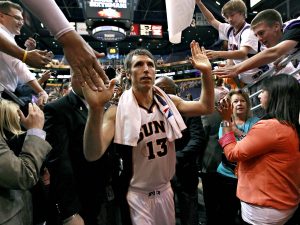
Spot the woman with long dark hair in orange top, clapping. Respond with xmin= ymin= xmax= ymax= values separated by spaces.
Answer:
xmin=219 ymin=74 xmax=300 ymax=225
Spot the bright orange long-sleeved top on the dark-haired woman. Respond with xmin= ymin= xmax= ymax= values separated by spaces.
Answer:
xmin=224 ymin=119 xmax=300 ymax=210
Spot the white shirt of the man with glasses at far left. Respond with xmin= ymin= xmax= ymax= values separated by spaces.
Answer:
xmin=0 ymin=24 xmax=35 ymax=92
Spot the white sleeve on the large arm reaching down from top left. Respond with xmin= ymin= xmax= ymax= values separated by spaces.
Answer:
xmin=22 ymin=0 xmax=74 ymax=39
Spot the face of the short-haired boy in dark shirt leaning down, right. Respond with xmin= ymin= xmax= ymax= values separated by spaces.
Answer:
xmin=253 ymin=22 xmax=280 ymax=48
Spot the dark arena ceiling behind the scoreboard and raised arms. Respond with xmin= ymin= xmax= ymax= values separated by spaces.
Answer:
xmin=15 ymin=0 xmax=300 ymax=55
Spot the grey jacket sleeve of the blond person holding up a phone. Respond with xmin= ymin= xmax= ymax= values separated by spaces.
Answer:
xmin=0 ymin=135 xmax=51 ymax=190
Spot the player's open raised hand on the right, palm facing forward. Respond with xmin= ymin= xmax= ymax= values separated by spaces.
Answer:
xmin=190 ymin=40 xmax=211 ymax=74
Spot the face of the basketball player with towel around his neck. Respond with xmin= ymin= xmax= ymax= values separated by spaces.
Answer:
xmin=129 ymin=55 xmax=155 ymax=91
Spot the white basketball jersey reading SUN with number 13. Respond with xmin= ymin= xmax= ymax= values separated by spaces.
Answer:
xmin=130 ymin=104 xmax=176 ymax=192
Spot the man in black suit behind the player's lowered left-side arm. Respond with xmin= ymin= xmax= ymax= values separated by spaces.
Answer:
xmin=44 ymin=74 xmax=117 ymax=225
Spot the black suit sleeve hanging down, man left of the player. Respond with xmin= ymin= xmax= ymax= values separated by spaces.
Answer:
xmin=44 ymin=105 xmax=80 ymax=219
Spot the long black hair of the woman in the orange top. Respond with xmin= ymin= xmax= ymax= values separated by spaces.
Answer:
xmin=262 ymin=74 xmax=300 ymax=136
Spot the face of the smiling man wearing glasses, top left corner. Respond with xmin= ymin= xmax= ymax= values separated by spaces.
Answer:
xmin=0 ymin=8 xmax=24 ymax=35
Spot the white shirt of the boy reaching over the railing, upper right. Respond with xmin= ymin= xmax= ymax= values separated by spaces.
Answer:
xmin=219 ymin=23 xmax=260 ymax=84
